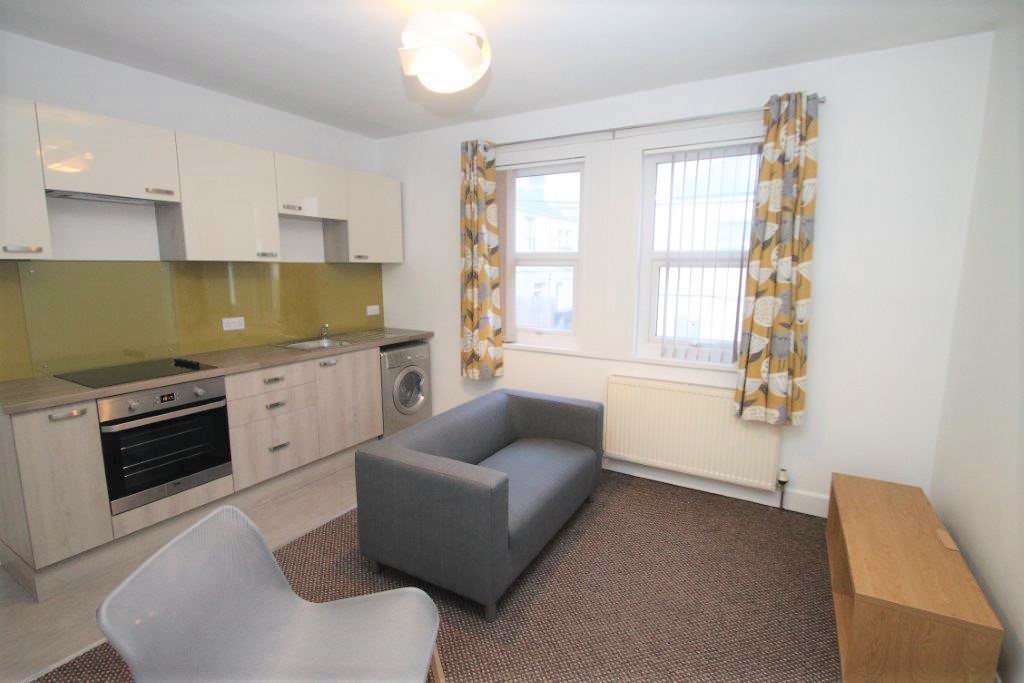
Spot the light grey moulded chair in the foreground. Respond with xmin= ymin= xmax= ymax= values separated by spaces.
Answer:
xmin=96 ymin=507 xmax=443 ymax=681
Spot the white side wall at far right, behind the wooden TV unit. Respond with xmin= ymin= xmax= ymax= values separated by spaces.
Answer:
xmin=932 ymin=4 xmax=1024 ymax=683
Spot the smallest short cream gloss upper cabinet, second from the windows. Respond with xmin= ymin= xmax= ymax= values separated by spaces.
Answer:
xmin=273 ymin=154 xmax=348 ymax=220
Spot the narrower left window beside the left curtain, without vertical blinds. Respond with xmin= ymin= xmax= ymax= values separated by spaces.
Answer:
xmin=502 ymin=163 xmax=583 ymax=339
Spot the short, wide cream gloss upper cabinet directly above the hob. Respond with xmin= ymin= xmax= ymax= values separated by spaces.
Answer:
xmin=36 ymin=103 xmax=179 ymax=202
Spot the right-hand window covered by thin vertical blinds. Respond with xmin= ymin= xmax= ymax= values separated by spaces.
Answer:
xmin=637 ymin=142 xmax=760 ymax=364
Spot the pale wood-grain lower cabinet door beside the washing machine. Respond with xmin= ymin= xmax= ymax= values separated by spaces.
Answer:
xmin=316 ymin=348 xmax=384 ymax=456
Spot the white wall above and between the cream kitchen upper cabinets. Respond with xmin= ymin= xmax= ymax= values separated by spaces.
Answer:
xmin=0 ymin=31 xmax=378 ymax=260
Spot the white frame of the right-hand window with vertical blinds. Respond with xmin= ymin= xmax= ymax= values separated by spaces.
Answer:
xmin=634 ymin=127 xmax=764 ymax=368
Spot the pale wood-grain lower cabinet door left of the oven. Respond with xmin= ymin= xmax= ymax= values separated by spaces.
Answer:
xmin=11 ymin=401 xmax=114 ymax=569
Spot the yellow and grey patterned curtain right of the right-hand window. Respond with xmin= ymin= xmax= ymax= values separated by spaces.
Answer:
xmin=735 ymin=92 xmax=818 ymax=425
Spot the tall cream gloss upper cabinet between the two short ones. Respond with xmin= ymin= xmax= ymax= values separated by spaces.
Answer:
xmin=157 ymin=132 xmax=281 ymax=261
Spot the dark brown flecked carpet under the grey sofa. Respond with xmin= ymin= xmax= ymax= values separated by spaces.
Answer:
xmin=37 ymin=472 xmax=840 ymax=682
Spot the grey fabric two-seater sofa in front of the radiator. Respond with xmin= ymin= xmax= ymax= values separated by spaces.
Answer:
xmin=355 ymin=389 xmax=604 ymax=621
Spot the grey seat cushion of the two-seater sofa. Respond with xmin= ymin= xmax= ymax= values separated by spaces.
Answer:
xmin=478 ymin=438 xmax=597 ymax=574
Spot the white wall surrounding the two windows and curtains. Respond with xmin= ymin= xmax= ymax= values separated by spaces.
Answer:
xmin=379 ymin=34 xmax=991 ymax=514
